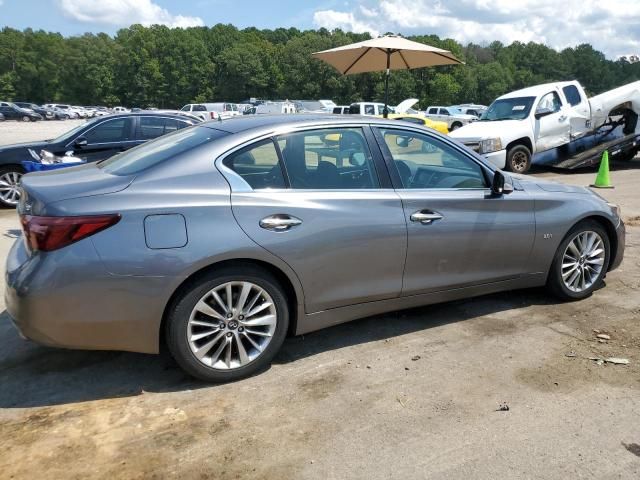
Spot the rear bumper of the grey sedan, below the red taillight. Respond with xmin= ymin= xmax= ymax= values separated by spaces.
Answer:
xmin=5 ymin=239 xmax=172 ymax=353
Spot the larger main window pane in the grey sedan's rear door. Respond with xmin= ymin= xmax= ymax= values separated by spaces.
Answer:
xmin=277 ymin=128 xmax=380 ymax=190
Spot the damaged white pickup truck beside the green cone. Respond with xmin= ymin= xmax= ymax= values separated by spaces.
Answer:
xmin=450 ymin=81 xmax=640 ymax=173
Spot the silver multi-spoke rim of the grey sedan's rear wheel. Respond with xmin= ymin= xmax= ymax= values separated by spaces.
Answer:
xmin=186 ymin=281 xmax=278 ymax=370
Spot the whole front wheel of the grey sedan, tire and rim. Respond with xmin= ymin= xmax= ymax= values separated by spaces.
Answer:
xmin=547 ymin=220 xmax=611 ymax=300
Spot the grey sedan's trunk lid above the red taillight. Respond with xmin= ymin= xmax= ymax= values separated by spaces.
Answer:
xmin=21 ymin=163 xmax=135 ymax=215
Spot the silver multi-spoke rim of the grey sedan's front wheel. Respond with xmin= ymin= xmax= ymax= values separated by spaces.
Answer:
xmin=562 ymin=230 xmax=605 ymax=293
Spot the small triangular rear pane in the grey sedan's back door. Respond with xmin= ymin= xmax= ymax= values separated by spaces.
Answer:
xmin=223 ymin=140 xmax=287 ymax=190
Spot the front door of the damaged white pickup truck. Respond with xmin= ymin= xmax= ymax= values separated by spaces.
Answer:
xmin=534 ymin=91 xmax=571 ymax=152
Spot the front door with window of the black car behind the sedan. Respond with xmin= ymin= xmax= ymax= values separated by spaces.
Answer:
xmin=67 ymin=116 xmax=139 ymax=162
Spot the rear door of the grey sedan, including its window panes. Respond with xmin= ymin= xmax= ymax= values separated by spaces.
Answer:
xmin=218 ymin=126 xmax=406 ymax=313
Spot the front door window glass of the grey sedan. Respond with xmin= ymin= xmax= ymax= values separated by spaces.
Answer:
xmin=379 ymin=129 xmax=488 ymax=189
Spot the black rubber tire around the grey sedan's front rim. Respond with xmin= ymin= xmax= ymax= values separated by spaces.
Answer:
xmin=547 ymin=220 xmax=611 ymax=301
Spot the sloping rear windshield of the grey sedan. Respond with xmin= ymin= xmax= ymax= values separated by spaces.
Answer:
xmin=98 ymin=127 xmax=229 ymax=175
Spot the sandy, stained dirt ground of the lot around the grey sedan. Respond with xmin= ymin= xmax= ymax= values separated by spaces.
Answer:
xmin=0 ymin=122 xmax=640 ymax=479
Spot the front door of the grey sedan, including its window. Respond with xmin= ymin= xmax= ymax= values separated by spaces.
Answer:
xmin=375 ymin=127 xmax=535 ymax=295
